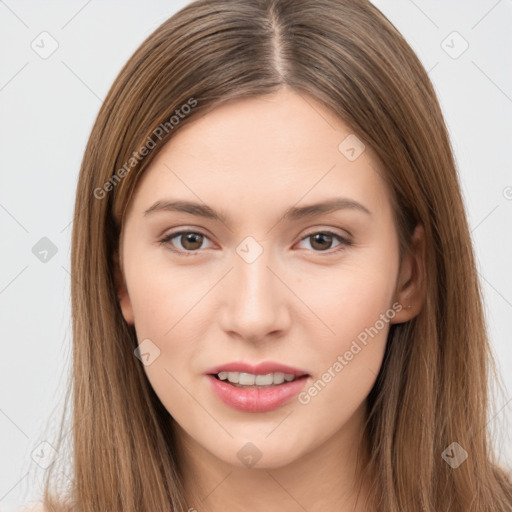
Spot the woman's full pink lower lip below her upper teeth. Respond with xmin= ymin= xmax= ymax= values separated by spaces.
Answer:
xmin=207 ymin=375 xmax=308 ymax=412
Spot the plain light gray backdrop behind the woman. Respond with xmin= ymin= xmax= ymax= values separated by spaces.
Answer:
xmin=0 ymin=0 xmax=512 ymax=511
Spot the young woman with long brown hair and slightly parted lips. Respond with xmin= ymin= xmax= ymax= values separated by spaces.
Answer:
xmin=37 ymin=0 xmax=512 ymax=512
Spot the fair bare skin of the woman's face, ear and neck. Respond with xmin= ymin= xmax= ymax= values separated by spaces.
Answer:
xmin=117 ymin=89 xmax=423 ymax=512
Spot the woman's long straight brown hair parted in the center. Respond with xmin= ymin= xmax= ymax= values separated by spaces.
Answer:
xmin=44 ymin=0 xmax=512 ymax=512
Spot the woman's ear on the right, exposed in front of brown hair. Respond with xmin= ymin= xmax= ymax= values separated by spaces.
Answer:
xmin=391 ymin=224 xmax=426 ymax=324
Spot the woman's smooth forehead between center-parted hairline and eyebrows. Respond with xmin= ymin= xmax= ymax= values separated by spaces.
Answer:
xmin=127 ymin=90 xmax=388 ymax=220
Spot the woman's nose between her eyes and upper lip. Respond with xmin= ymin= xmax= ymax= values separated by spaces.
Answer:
xmin=220 ymin=245 xmax=292 ymax=342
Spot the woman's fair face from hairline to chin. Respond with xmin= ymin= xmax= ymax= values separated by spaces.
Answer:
xmin=120 ymin=90 xmax=422 ymax=467
